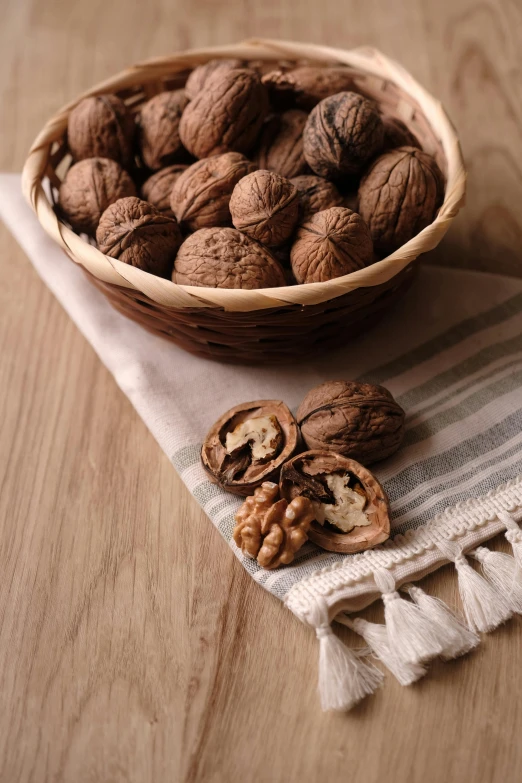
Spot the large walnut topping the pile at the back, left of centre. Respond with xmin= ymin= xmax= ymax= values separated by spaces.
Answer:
xmin=179 ymin=68 xmax=268 ymax=158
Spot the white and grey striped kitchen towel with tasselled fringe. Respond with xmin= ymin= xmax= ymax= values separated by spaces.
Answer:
xmin=0 ymin=175 xmax=522 ymax=709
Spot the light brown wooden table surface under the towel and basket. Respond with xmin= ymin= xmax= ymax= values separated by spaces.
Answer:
xmin=0 ymin=0 xmax=522 ymax=783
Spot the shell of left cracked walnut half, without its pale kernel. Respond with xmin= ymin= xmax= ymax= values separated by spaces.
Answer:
xmin=201 ymin=400 xmax=299 ymax=495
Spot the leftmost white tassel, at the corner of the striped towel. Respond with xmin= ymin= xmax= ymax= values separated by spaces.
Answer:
xmin=309 ymin=596 xmax=384 ymax=711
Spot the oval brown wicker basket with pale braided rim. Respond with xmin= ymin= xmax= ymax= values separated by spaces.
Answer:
xmin=23 ymin=41 xmax=466 ymax=363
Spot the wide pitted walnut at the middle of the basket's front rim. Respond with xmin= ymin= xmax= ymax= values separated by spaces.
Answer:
xmin=172 ymin=228 xmax=286 ymax=290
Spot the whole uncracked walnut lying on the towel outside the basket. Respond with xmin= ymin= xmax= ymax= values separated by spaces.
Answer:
xmin=296 ymin=381 xmax=404 ymax=465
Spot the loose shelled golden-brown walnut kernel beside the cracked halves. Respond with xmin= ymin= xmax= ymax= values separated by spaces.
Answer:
xmin=233 ymin=481 xmax=314 ymax=568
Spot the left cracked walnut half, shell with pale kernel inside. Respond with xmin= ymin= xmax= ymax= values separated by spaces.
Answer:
xmin=201 ymin=400 xmax=299 ymax=495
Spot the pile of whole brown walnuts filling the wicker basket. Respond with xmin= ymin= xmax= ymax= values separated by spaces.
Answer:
xmin=58 ymin=60 xmax=444 ymax=289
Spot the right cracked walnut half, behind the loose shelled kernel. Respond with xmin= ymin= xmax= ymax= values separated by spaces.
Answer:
xmin=279 ymin=451 xmax=390 ymax=554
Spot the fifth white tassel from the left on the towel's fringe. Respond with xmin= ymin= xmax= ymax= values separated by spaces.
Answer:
xmin=437 ymin=541 xmax=512 ymax=633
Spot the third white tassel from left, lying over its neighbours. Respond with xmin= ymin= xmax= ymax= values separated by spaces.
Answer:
xmin=373 ymin=568 xmax=443 ymax=664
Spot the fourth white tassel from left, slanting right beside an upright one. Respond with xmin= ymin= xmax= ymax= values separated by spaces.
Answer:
xmin=404 ymin=585 xmax=480 ymax=661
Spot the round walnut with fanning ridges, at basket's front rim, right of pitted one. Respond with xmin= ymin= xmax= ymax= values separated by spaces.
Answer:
xmin=290 ymin=207 xmax=374 ymax=283
